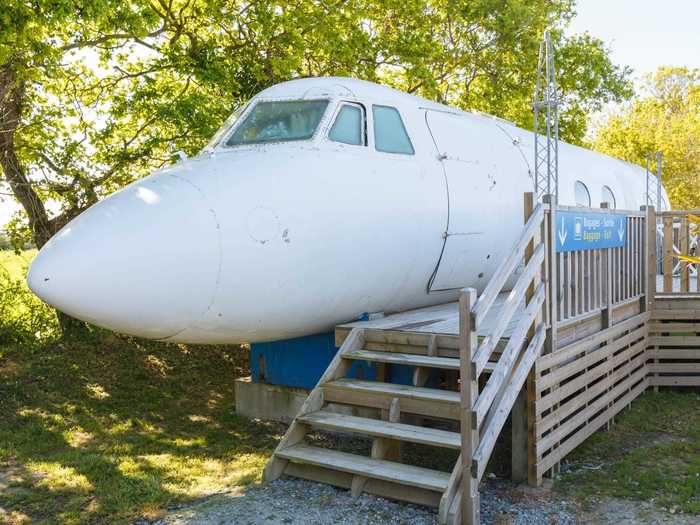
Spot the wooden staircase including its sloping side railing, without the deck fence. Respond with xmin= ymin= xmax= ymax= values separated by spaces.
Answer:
xmin=264 ymin=194 xmax=554 ymax=525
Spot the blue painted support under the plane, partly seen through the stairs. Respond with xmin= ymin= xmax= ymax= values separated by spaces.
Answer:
xmin=250 ymin=332 xmax=430 ymax=389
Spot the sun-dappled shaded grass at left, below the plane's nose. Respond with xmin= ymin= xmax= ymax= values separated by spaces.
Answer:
xmin=0 ymin=335 xmax=281 ymax=524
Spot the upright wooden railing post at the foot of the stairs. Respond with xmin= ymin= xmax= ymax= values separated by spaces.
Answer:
xmin=459 ymin=288 xmax=480 ymax=525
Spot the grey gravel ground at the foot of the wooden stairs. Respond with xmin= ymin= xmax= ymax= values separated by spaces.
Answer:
xmin=154 ymin=479 xmax=579 ymax=525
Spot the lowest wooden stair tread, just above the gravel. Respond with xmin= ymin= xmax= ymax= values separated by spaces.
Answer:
xmin=276 ymin=444 xmax=450 ymax=492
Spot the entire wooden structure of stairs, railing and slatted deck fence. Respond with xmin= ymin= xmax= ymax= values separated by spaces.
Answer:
xmin=265 ymin=193 xmax=700 ymax=525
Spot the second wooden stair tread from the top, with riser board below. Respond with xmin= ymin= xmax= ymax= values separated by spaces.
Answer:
xmin=322 ymin=379 xmax=460 ymax=419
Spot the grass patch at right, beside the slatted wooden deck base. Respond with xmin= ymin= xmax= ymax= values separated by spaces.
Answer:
xmin=557 ymin=392 xmax=700 ymax=514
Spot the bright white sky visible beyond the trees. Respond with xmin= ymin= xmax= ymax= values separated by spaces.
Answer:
xmin=0 ymin=0 xmax=700 ymax=229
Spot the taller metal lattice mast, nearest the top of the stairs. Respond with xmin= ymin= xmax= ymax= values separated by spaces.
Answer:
xmin=533 ymin=31 xmax=559 ymax=204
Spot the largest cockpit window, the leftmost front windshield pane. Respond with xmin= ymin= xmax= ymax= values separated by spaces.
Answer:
xmin=226 ymin=100 xmax=328 ymax=146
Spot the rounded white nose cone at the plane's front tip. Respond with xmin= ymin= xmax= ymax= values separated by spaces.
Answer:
xmin=27 ymin=170 xmax=221 ymax=339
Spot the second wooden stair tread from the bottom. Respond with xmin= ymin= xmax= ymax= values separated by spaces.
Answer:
xmin=299 ymin=410 xmax=461 ymax=450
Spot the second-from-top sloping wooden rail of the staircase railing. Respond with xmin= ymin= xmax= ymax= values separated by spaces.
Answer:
xmin=472 ymin=243 xmax=544 ymax=379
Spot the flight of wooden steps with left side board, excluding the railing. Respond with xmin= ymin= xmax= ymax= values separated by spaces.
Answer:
xmin=265 ymin=328 xmax=461 ymax=522
